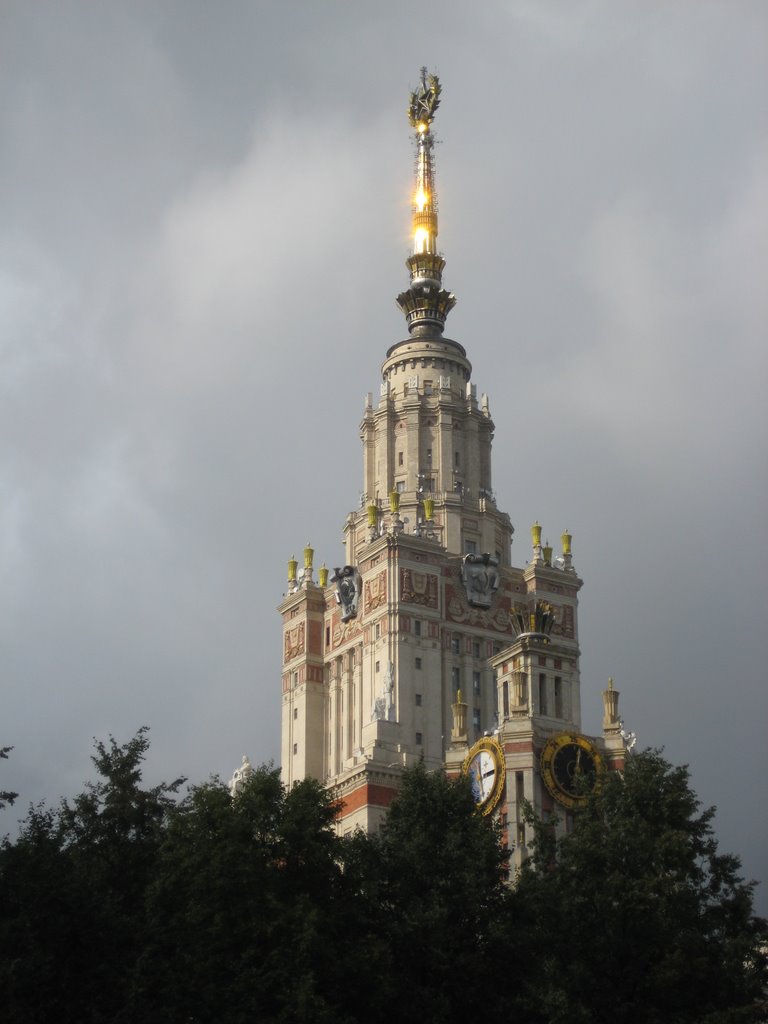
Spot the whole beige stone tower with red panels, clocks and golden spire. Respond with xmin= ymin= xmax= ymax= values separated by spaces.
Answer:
xmin=280 ymin=71 xmax=626 ymax=843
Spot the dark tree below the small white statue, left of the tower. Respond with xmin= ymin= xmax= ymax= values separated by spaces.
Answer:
xmin=135 ymin=768 xmax=354 ymax=1022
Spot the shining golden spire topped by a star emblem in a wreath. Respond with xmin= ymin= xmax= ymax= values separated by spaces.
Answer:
xmin=397 ymin=68 xmax=456 ymax=336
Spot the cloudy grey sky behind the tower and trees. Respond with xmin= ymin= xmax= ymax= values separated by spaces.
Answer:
xmin=0 ymin=0 xmax=768 ymax=912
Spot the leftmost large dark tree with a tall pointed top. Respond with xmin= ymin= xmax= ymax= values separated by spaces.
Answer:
xmin=0 ymin=729 xmax=182 ymax=1024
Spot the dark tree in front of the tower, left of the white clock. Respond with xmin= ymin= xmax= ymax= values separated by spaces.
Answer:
xmin=374 ymin=764 xmax=510 ymax=1022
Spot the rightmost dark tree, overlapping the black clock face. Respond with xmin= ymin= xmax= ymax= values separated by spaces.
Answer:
xmin=516 ymin=751 xmax=766 ymax=1024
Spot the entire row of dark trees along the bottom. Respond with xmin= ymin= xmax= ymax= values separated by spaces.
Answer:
xmin=0 ymin=730 xmax=768 ymax=1024
